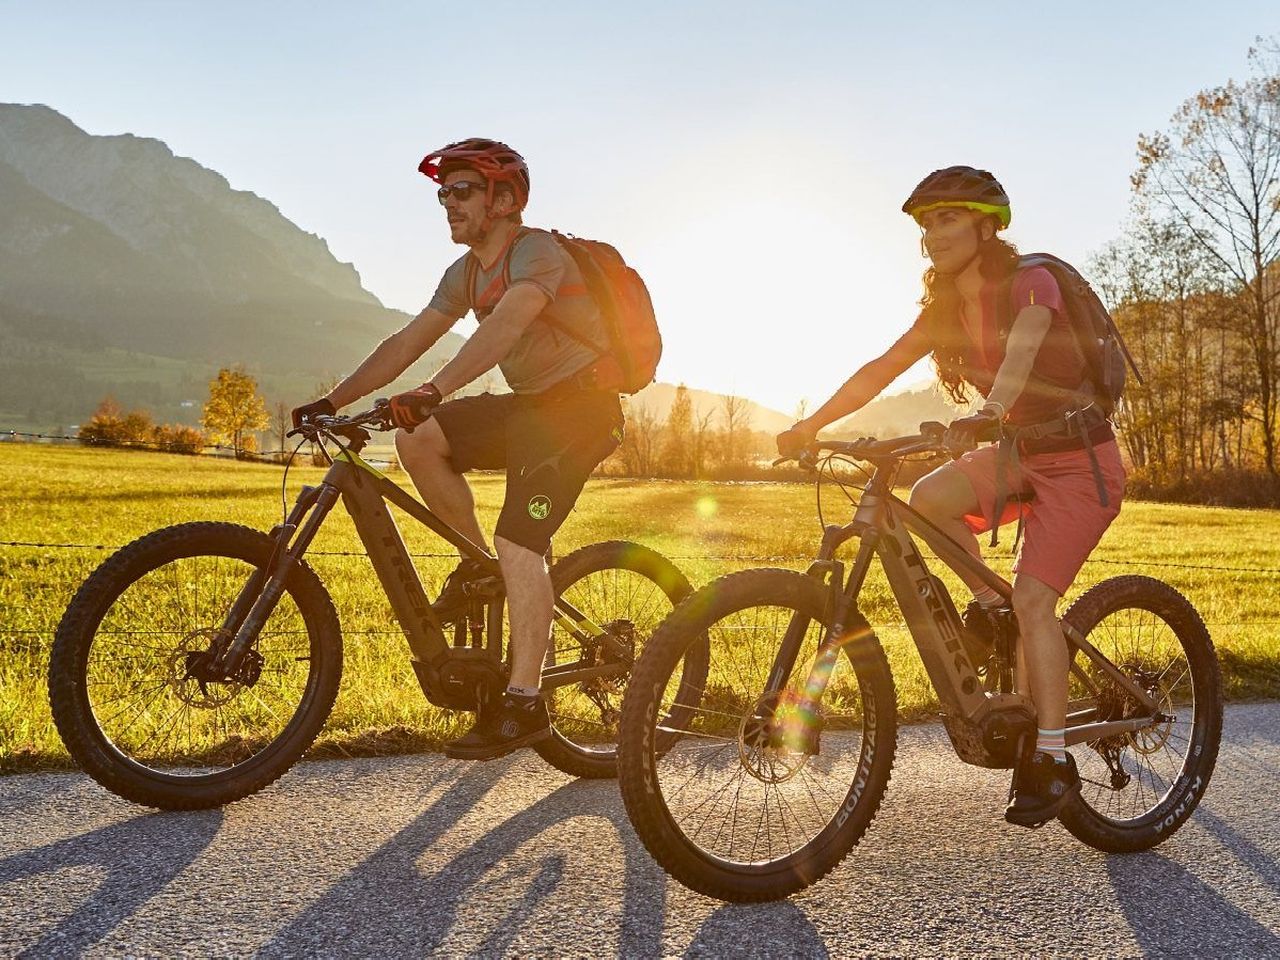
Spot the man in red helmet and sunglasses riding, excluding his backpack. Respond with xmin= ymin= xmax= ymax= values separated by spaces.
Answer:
xmin=293 ymin=138 xmax=622 ymax=760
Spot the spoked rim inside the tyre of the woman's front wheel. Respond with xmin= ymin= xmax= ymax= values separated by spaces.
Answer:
xmin=654 ymin=604 xmax=868 ymax=873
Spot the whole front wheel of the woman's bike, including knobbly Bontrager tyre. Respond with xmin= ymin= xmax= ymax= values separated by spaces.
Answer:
xmin=620 ymin=570 xmax=897 ymax=902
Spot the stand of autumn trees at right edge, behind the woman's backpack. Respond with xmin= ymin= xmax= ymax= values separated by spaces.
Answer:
xmin=1091 ymin=40 xmax=1280 ymax=506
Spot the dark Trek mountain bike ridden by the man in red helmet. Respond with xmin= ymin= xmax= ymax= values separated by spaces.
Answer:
xmin=49 ymin=401 xmax=707 ymax=809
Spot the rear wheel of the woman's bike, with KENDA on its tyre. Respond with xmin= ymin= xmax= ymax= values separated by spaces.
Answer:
xmin=1059 ymin=576 xmax=1222 ymax=852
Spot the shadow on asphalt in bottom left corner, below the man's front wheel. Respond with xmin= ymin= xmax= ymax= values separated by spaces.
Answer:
xmin=0 ymin=810 xmax=223 ymax=956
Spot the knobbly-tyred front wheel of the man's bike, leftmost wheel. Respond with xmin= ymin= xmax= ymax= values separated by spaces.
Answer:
xmin=49 ymin=524 xmax=342 ymax=810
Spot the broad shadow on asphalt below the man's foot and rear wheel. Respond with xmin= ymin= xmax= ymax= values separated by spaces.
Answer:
xmin=260 ymin=763 xmax=667 ymax=957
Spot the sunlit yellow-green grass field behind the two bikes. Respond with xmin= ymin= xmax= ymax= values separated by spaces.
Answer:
xmin=0 ymin=444 xmax=1280 ymax=772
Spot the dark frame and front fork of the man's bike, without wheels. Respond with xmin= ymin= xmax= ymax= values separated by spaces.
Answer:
xmin=219 ymin=443 xmax=626 ymax=709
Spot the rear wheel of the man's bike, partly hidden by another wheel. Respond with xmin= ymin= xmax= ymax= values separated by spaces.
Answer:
xmin=534 ymin=540 xmax=707 ymax=778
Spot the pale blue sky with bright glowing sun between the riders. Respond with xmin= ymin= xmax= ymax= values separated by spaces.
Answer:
xmin=0 ymin=0 xmax=1280 ymax=412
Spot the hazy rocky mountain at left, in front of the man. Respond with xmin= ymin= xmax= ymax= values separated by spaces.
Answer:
xmin=0 ymin=104 xmax=462 ymax=421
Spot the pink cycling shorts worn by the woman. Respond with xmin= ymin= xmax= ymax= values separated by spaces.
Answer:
xmin=943 ymin=440 xmax=1125 ymax=595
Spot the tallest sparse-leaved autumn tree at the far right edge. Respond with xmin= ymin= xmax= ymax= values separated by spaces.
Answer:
xmin=1133 ymin=46 xmax=1280 ymax=476
